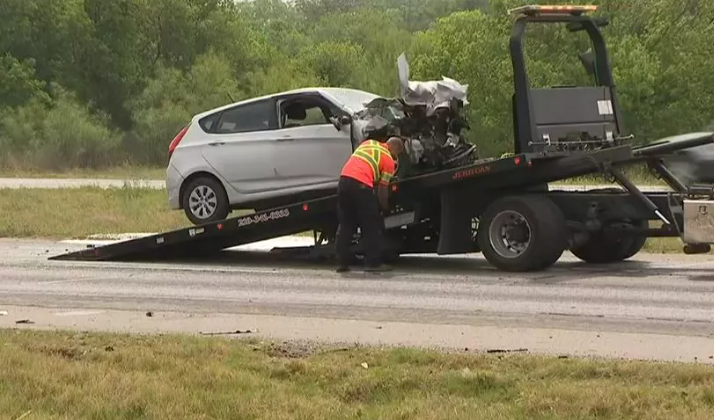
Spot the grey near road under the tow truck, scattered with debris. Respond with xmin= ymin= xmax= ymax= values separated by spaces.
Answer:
xmin=0 ymin=239 xmax=714 ymax=363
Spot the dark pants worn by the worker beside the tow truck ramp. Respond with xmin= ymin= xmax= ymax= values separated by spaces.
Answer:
xmin=336 ymin=177 xmax=384 ymax=266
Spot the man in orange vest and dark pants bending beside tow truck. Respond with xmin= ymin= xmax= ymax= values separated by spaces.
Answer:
xmin=336 ymin=137 xmax=404 ymax=273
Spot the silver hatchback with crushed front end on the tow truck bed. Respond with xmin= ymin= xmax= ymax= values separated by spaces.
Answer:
xmin=166 ymin=55 xmax=476 ymax=224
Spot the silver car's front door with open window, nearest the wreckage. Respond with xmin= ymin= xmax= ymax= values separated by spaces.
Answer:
xmin=273 ymin=94 xmax=352 ymax=190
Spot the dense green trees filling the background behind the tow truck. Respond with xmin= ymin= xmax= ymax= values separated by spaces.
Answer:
xmin=0 ymin=0 xmax=714 ymax=170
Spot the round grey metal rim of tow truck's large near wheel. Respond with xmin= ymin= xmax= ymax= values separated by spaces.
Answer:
xmin=488 ymin=210 xmax=531 ymax=258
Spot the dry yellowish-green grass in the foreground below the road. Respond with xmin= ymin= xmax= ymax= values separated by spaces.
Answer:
xmin=0 ymin=330 xmax=714 ymax=420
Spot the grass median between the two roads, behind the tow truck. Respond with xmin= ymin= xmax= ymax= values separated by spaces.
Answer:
xmin=0 ymin=187 xmax=682 ymax=253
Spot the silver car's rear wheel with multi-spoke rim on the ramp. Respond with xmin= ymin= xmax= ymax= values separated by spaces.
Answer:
xmin=181 ymin=176 xmax=230 ymax=225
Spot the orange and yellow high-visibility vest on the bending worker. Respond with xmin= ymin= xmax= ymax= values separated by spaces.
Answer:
xmin=341 ymin=140 xmax=396 ymax=187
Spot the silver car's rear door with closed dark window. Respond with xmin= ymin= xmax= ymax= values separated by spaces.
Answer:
xmin=202 ymin=99 xmax=280 ymax=194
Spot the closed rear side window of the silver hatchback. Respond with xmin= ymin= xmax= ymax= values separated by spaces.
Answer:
xmin=214 ymin=100 xmax=277 ymax=134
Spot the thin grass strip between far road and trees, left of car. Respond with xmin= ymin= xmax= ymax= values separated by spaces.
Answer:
xmin=0 ymin=165 xmax=166 ymax=180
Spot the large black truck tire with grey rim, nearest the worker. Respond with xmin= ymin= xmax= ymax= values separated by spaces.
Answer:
xmin=477 ymin=195 xmax=568 ymax=272
